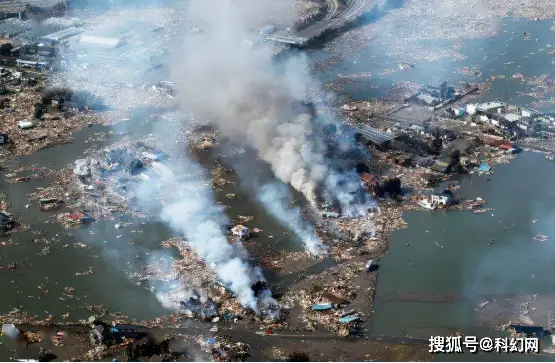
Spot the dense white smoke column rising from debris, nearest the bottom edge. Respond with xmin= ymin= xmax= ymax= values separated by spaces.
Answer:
xmin=138 ymin=161 xmax=262 ymax=311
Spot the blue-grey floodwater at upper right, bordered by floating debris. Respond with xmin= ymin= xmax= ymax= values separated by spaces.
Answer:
xmin=310 ymin=20 xmax=555 ymax=111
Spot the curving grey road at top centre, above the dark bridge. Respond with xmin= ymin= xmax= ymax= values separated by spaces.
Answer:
xmin=266 ymin=0 xmax=387 ymax=45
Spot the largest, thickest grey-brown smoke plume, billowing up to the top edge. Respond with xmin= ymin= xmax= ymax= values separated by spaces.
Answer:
xmin=174 ymin=0 xmax=329 ymax=206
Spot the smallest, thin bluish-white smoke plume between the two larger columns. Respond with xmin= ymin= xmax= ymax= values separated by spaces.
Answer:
xmin=258 ymin=183 xmax=326 ymax=255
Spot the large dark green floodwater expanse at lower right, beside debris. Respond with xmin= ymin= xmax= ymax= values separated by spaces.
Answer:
xmin=371 ymin=152 xmax=555 ymax=361
